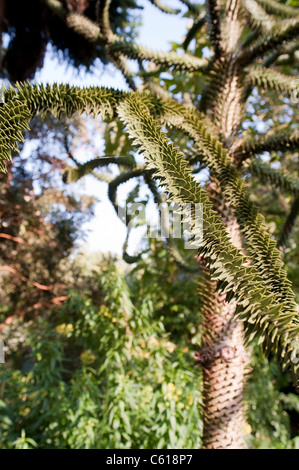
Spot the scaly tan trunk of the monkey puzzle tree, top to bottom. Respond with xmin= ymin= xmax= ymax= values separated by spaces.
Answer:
xmin=197 ymin=0 xmax=249 ymax=449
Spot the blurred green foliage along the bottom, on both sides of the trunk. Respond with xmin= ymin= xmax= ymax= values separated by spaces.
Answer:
xmin=0 ymin=235 xmax=299 ymax=449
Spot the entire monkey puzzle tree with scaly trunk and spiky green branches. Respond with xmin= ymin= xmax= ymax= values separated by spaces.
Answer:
xmin=0 ymin=0 xmax=299 ymax=448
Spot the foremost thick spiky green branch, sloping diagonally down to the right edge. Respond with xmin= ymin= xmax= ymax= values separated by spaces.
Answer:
xmin=118 ymin=96 xmax=299 ymax=388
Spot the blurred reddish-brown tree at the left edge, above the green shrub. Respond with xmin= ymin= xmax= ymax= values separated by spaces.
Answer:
xmin=0 ymin=114 xmax=94 ymax=323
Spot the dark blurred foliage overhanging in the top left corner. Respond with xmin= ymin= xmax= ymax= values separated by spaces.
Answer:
xmin=0 ymin=0 xmax=142 ymax=82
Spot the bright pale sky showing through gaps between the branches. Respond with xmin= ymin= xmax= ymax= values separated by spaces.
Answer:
xmin=35 ymin=0 xmax=189 ymax=255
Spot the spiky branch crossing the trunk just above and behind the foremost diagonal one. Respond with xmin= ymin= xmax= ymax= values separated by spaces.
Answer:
xmin=149 ymin=101 xmax=296 ymax=318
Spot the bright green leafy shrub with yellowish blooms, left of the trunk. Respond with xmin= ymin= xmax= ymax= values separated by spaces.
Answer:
xmin=0 ymin=260 xmax=201 ymax=448
